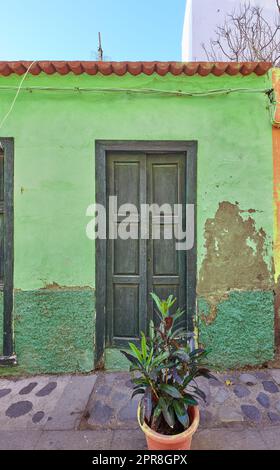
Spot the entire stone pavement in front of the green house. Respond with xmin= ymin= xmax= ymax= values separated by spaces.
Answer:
xmin=0 ymin=369 xmax=280 ymax=450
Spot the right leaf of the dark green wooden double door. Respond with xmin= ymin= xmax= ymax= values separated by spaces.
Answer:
xmin=147 ymin=154 xmax=186 ymax=326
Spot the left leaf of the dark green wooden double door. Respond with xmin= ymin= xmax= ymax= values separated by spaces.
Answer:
xmin=106 ymin=152 xmax=146 ymax=347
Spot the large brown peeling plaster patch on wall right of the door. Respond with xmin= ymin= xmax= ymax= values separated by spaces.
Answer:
xmin=198 ymin=201 xmax=273 ymax=295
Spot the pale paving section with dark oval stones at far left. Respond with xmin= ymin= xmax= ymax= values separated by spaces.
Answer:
xmin=0 ymin=375 xmax=96 ymax=431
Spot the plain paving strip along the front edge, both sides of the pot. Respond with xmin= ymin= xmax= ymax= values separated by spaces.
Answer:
xmin=0 ymin=427 xmax=280 ymax=451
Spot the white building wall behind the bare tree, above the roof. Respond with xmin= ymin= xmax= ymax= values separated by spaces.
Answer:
xmin=182 ymin=0 xmax=277 ymax=62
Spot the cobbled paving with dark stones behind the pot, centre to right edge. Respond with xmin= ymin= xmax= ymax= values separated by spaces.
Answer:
xmin=82 ymin=370 xmax=280 ymax=432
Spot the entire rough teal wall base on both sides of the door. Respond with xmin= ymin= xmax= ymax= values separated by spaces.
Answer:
xmin=0 ymin=289 xmax=274 ymax=375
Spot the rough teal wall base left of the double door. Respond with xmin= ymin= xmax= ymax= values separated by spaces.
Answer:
xmin=1 ymin=289 xmax=95 ymax=373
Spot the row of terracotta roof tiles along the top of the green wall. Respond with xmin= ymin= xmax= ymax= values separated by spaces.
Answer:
xmin=0 ymin=61 xmax=272 ymax=77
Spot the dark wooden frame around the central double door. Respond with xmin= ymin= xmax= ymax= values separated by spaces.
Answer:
xmin=95 ymin=140 xmax=197 ymax=369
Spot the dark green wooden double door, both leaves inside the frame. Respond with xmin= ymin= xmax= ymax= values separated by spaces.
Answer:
xmin=106 ymin=151 xmax=186 ymax=347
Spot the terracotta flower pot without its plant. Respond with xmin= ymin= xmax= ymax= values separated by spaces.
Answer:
xmin=137 ymin=404 xmax=199 ymax=450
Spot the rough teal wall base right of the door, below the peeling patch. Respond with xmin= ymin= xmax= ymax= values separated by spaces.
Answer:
xmin=198 ymin=291 xmax=274 ymax=369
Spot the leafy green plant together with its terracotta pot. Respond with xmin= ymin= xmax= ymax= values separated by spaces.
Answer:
xmin=122 ymin=293 xmax=215 ymax=450
